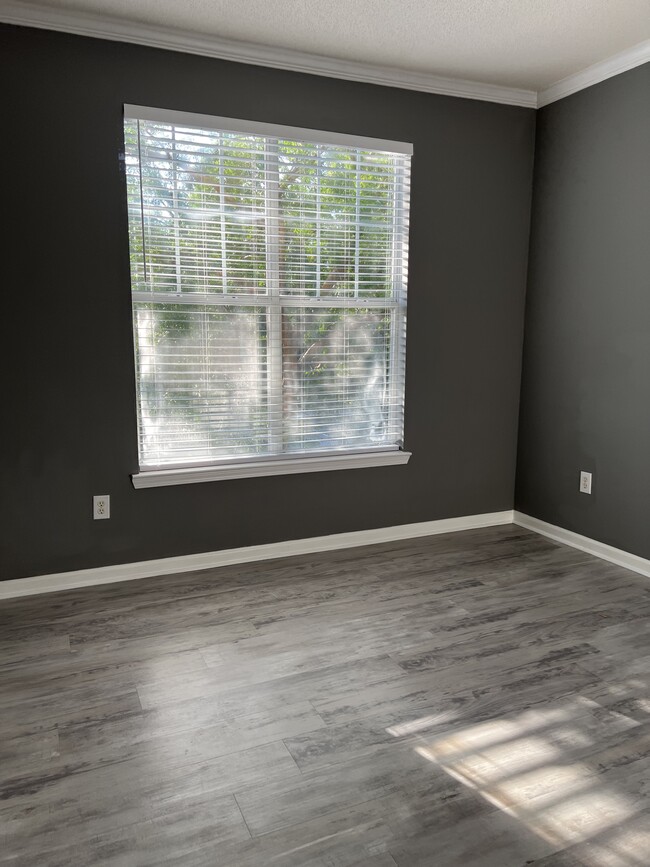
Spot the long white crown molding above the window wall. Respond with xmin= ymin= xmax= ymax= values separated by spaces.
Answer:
xmin=0 ymin=0 xmax=537 ymax=108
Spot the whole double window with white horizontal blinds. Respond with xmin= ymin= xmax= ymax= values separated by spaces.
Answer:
xmin=124 ymin=106 xmax=410 ymax=487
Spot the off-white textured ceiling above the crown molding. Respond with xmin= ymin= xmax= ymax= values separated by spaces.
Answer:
xmin=10 ymin=0 xmax=650 ymax=90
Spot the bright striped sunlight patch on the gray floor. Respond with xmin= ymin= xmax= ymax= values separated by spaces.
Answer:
xmin=388 ymin=697 xmax=650 ymax=867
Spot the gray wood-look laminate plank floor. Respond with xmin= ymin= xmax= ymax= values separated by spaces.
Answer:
xmin=0 ymin=526 xmax=650 ymax=867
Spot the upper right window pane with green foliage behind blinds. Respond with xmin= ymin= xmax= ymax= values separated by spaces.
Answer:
xmin=278 ymin=140 xmax=394 ymax=298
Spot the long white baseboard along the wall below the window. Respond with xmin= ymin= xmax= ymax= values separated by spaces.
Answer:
xmin=0 ymin=511 xmax=512 ymax=599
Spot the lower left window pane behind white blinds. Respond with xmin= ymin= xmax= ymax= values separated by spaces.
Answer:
xmin=134 ymin=304 xmax=269 ymax=466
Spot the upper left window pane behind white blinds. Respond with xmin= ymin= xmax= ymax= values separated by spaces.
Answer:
xmin=126 ymin=121 xmax=266 ymax=294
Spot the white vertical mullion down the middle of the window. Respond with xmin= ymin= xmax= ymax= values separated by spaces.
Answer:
xmin=266 ymin=139 xmax=284 ymax=453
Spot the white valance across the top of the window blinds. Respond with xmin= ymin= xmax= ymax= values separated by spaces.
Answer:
xmin=124 ymin=105 xmax=413 ymax=156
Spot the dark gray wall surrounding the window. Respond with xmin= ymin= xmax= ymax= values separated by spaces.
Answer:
xmin=0 ymin=26 xmax=535 ymax=578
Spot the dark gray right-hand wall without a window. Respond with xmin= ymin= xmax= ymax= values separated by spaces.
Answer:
xmin=516 ymin=64 xmax=650 ymax=557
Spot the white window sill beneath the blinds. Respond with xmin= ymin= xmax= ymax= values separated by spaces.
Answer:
xmin=131 ymin=449 xmax=411 ymax=488
